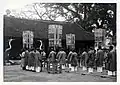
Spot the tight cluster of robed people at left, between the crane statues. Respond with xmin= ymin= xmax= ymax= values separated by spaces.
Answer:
xmin=20 ymin=49 xmax=46 ymax=72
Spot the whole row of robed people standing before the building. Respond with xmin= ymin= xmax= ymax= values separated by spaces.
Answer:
xmin=20 ymin=46 xmax=117 ymax=76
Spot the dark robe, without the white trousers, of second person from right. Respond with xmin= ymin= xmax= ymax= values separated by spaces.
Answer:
xmin=96 ymin=50 xmax=104 ymax=67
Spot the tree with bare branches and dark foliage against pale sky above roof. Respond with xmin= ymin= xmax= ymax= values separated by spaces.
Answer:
xmin=5 ymin=3 xmax=116 ymax=35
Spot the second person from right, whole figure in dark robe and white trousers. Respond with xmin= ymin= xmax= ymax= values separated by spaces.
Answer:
xmin=96 ymin=46 xmax=104 ymax=72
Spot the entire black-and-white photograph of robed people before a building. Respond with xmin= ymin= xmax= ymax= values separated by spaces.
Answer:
xmin=3 ymin=0 xmax=117 ymax=82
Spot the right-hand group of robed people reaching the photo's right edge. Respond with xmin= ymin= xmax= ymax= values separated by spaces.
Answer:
xmin=80 ymin=46 xmax=117 ymax=76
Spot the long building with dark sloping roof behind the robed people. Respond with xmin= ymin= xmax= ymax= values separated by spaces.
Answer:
xmin=3 ymin=16 xmax=94 ymax=57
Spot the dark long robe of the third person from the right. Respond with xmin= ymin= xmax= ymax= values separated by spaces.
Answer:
xmin=87 ymin=50 xmax=95 ymax=67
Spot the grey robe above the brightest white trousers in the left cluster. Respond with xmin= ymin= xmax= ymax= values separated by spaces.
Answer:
xmin=34 ymin=51 xmax=42 ymax=67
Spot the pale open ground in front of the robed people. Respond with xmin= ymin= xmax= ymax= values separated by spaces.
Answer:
xmin=4 ymin=65 xmax=116 ymax=82
